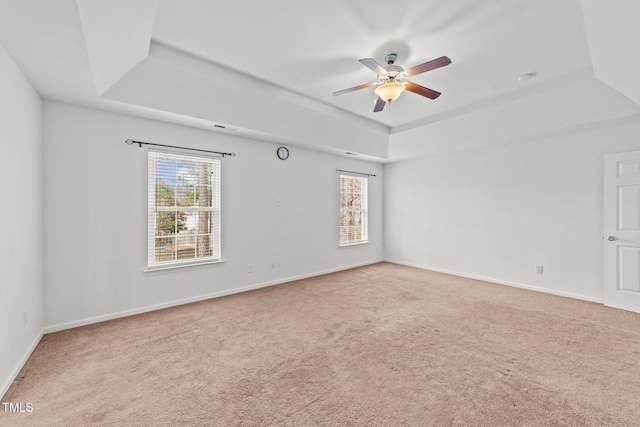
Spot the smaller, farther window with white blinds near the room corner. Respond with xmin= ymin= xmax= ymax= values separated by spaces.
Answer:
xmin=340 ymin=175 xmax=368 ymax=246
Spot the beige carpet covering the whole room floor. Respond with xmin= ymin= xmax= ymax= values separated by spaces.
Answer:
xmin=0 ymin=263 xmax=640 ymax=426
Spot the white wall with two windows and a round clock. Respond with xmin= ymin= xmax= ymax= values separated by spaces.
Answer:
xmin=44 ymin=101 xmax=383 ymax=331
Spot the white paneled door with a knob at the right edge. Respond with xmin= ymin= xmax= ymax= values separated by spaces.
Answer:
xmin=603 ymin=151 xmax=640 ymax=312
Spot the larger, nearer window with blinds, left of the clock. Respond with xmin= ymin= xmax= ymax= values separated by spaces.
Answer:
xmin=148 ymin=151 xmax=220 ymax=269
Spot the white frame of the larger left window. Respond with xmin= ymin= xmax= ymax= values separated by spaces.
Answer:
xmin=145 ymin=149 xmax=224 ymax=272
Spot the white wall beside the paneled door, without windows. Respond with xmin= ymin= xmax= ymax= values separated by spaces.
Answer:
xmin=384 ymin=116 xmax=640 ymax=301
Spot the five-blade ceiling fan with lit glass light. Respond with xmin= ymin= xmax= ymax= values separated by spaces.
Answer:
xmin=333 ymin=53 xmax=451 ymax=113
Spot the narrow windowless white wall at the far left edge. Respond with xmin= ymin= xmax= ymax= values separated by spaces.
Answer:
xmin=0 ymin=46 xmax=43 ymax=398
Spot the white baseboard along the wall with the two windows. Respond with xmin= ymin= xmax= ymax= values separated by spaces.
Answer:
xmin=44 ymin=259 xmax=384 ymax=334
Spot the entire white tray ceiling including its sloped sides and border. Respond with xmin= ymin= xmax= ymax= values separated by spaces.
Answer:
xmin=0 ymin=0 xmax=638 ymax=161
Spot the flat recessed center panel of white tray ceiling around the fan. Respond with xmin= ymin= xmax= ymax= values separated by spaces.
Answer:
xmin=152 ymin=0 xmax=591 ymax=126
